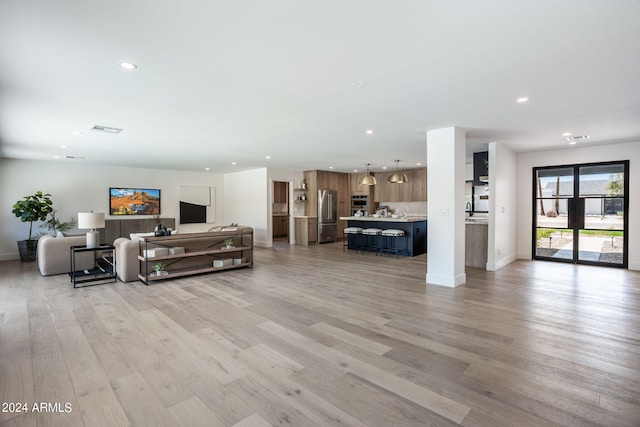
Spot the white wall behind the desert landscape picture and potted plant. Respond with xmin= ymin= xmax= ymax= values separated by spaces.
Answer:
xmin=0 ymin=159 xmax=224 ymax=260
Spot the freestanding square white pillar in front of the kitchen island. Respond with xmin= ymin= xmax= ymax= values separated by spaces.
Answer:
xmin=427 ymin=127 xmax=467 ymax=287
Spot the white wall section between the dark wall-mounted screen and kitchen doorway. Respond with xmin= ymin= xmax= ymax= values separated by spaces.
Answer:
xmin=224 ymin=168 xmax=273 ymax=247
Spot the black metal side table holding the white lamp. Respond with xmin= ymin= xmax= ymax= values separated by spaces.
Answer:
xmin=69 ymin=245 xmax=116 ymax=288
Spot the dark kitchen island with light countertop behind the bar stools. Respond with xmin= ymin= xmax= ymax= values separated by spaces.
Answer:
xmin=339 ymin=216 xmax=427 ymax=256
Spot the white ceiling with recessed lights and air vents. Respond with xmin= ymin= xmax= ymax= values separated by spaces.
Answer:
xmin=0 ymin=0 xmax=640 ymax=172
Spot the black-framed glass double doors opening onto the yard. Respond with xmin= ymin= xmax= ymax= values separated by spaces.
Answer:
xmin=532 ymin=161 xmax=629 ymax=268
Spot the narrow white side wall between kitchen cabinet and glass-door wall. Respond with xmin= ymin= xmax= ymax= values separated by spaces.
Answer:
xmin=487 ymin=142 xmax=517 ymax=271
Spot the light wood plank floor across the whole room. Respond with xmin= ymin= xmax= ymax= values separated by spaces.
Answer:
xmin=0 ymin=243 xmax=640 ymax=427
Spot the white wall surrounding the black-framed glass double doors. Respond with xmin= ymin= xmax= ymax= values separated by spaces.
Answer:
xmin=517 ymin=142 xmax=640 ymax=270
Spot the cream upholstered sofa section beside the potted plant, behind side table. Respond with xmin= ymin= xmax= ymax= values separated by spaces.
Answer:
xmin=36 ymin=234 xmax=96 ymax=276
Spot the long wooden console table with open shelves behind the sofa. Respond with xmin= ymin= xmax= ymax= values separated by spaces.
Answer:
xmin=138 ymin=226 xmax=253 ymax=285
